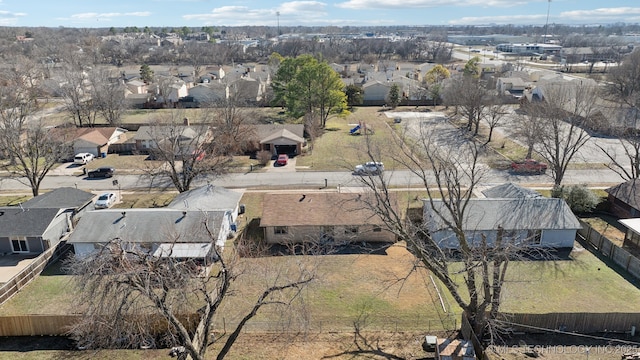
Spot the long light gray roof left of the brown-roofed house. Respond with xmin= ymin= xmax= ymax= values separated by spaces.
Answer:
xmin=69 ymin=208 xmax=224 ymax=243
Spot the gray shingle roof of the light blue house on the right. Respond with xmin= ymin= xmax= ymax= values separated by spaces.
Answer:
xmin=424 ymin=197 xmax=581 ymax=231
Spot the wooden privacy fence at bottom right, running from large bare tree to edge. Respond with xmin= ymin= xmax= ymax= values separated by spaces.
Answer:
xmin=501 ymin=313 xmax=640 ymax=334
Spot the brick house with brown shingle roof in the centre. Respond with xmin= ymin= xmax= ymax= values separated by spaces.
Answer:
xmin=260 ymin=192 xmax=397 ymax=244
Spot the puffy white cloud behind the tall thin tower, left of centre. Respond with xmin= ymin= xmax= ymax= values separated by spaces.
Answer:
xmin=182 ymin=1 xmax=328 ymax=26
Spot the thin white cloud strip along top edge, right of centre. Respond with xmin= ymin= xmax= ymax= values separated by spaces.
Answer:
xmin=336 ymin=0 xmax=532 ymax=9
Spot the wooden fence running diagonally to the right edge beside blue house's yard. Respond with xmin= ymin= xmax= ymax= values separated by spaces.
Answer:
xmin=578 ymin=220 xmax=640 ymax=280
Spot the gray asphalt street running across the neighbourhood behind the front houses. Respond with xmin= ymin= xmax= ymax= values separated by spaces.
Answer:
xmin=0 ymin=169 xmax=622 ymax=193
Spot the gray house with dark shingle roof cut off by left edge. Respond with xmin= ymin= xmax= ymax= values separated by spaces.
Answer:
xmin=0 ymin=206 xmax=71 ymax=254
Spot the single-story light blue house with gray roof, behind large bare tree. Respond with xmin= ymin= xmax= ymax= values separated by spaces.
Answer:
xmin=423 ymin=197 xmax=581 ymax=250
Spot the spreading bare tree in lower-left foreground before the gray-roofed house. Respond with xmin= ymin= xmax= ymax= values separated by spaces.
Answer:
xmin=66 ymin=225 xmax=315 ymax=360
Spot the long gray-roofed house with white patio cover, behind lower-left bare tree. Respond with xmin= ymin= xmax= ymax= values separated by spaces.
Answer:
xmin=68 ymin=208 xmax=231 ymax=263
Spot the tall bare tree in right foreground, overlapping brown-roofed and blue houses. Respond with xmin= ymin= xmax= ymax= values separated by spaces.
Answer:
xmin=362 ymin=127 xmax=527 ymax=358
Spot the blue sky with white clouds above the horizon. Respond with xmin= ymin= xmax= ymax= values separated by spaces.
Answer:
xmin=0 ymin=0 xmax=640 ymax=28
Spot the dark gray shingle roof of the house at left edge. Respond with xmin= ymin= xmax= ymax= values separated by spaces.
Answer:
xmin=0 ymin=206 xmax=60 ymax=237
